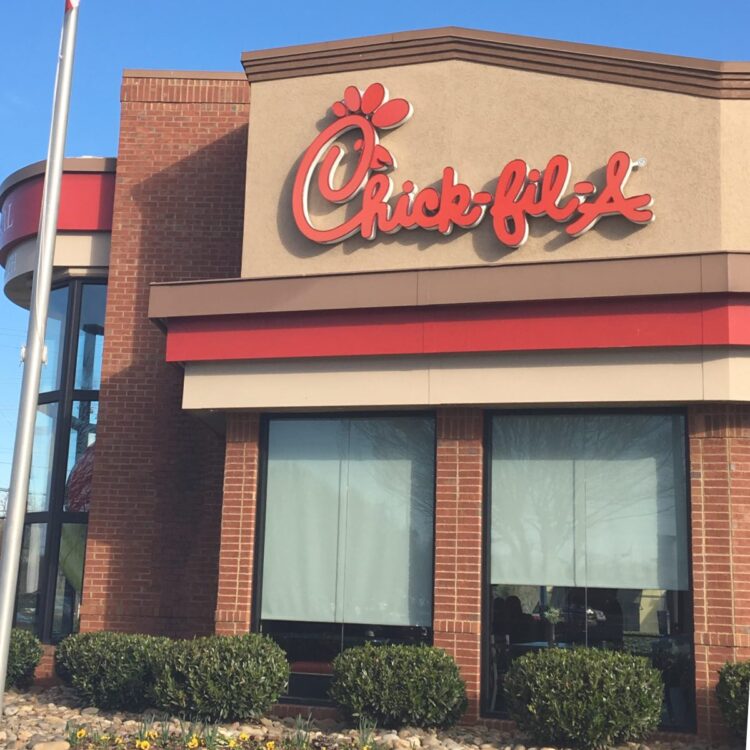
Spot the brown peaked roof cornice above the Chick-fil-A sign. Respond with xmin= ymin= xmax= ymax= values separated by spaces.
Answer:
xmin=241 ymin=27 xmax=750 ymax=99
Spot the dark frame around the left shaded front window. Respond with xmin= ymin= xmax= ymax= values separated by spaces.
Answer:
xmin=250 ymin=409 xmax=438 ymax=705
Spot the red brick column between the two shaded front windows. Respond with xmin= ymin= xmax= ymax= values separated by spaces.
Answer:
xmin=433 ymin=409 xmax=483 ymax=721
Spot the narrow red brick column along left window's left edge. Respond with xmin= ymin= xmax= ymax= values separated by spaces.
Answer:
xmin=216 ymin=413 xmax=260 ymax=635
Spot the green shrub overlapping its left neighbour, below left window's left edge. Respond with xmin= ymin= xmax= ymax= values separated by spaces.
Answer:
xmin=154 ymin=633 xmax=289 ymax=721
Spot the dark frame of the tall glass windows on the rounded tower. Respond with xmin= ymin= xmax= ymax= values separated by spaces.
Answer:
xmin=13 ymin=276 xmax=107 ymax=644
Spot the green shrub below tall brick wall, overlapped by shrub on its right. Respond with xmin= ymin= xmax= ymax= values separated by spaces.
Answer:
xmin=55 ymin=632 xmax=169 ymax=711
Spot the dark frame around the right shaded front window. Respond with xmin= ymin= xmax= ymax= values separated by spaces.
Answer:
xmin=479 ymin=406 xmax=697 ymax=734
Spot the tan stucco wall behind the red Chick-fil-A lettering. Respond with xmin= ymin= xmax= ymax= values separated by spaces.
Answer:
xmin=242 ymin=61 xmax=750 ymax=277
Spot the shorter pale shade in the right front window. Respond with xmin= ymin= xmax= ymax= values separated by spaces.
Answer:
xmin=491 ymin=414 xmax=688 ymax=590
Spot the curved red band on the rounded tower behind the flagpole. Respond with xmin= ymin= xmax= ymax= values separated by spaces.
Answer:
xmin=0 ymin=172 xmax=115 ymax=264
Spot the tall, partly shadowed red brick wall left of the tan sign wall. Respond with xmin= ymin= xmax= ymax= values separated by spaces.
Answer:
xmin=81 ymin=73 xmax=249 ymax=635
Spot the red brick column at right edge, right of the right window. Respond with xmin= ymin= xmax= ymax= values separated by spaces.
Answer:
xmin=688 ymin=404 xmax=750 ymax=741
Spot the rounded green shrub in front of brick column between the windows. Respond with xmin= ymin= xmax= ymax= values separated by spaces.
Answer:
xmin=331 ymin=644 xmax=466 ymax=727
